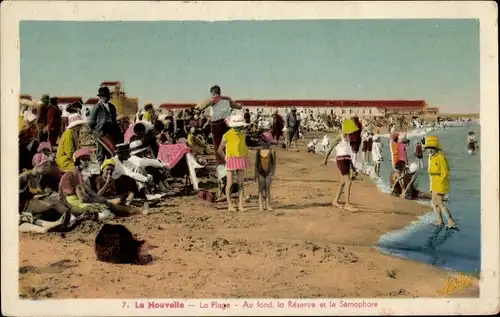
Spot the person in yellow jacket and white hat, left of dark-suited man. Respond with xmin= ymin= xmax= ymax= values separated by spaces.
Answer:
xmin=56 ymin=115 xmax=87 ymax=172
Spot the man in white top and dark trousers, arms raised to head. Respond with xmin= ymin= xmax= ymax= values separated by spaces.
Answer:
xmin=195 ymin=86 xmax=242 ymax=165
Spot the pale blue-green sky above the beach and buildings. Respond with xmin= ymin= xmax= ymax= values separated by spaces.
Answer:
xmin=20 ymin=19 xmax=480 ymax=113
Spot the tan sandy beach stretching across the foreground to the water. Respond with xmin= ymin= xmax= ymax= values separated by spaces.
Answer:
xmin=19 ymin=137 xmax=479 ymax=299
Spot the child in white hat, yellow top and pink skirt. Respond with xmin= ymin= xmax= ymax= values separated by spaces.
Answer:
xmin=218 ymin=114 xmax=250 ymax=211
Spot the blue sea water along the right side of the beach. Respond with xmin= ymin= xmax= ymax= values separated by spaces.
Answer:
xmin=372 ymin=124 xmax=481 ymax=274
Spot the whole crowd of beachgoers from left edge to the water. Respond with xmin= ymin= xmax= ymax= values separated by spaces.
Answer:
xmin=19 ymin=86 xmax=468 ymax=256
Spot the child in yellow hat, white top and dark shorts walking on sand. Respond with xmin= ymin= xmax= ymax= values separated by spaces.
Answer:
xmin=323 ymin=119 xmax=359 ymax=211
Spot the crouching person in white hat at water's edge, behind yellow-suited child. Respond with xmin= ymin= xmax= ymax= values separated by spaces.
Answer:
xmin=390 ymin=161 xmax=448 ymax=200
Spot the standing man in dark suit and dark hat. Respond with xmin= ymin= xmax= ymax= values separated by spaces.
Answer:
xmin=88 ymin=87 xmax=123 ymax=165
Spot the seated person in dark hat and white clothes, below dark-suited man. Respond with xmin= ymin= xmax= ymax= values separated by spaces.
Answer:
xmin=111 ymin=143 xmax=154 ymax=201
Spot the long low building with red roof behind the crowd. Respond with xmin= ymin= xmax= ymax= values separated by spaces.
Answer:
xmin=160 ymin=99 xmax=439 ymax=117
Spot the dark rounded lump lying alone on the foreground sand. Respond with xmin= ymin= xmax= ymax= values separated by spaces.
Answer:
xmin=95 ymin=224 xmax=152 ymax=265
